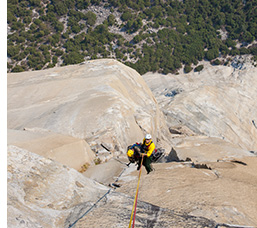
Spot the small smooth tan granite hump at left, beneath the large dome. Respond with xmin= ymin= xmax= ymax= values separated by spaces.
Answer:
xmin=7 ymin=129 xmax=95 ymax=170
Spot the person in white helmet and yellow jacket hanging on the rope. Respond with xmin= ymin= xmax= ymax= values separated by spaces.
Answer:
xmin=137 ymin=134 xmax=155 ymax=174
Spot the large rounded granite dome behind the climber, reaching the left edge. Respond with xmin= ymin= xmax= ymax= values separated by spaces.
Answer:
xmin=8 ymin=59 xmax=171 ymax=163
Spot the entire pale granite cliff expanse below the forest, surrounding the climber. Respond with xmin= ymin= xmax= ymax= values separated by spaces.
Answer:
xmin=7 ymin=60 xmax=257 ymax=228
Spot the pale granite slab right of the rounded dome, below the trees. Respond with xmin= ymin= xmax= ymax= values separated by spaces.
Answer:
xmin=143 ymin=57 xmax=257 ymax=151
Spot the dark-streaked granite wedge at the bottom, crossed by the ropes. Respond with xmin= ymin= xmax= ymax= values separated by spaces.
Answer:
xmin=76 ymin=192 xmax=217 ymax=228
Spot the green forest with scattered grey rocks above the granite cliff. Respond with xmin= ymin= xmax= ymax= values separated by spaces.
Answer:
xmin=7 ymin=0 xmax=257 ymax=74
